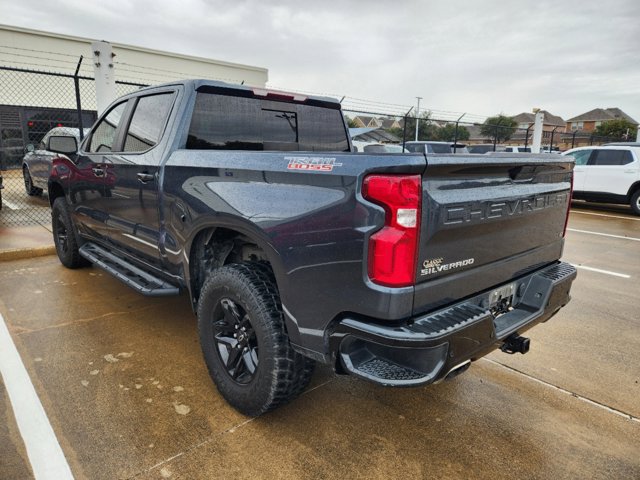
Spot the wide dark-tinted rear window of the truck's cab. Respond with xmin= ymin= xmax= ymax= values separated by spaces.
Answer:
xmin=187 ymin=92 xmax=349 ymax=151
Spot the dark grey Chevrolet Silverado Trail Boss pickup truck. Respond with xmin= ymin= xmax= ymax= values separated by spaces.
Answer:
xmin=48 ymin=80 xmax=576 ymax=415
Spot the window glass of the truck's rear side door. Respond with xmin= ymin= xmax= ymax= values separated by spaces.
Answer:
xmin=124 ymin=92 xmax=173 ymax=152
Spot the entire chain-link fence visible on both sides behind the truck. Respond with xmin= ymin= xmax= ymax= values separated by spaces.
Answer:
xmin=0 ymin=59 xmax=611 ymax=226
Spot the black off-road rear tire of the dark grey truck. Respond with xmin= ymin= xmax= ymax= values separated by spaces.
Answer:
xmin=197 ymin=263 xmax=312 ymax=416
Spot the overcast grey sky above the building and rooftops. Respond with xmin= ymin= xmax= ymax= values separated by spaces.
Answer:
xmin=0 ymin=0 xmax=640 ymax=121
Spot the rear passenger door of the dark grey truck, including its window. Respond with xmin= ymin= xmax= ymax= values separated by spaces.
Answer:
xmin=100 ymin=89 xmax=176 ymax=263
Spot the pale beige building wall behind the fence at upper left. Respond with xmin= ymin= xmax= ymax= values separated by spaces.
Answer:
xmin=0 ymin=25 xmax=268 ymax=110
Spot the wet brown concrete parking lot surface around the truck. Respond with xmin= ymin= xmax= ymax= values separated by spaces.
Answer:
xmin=0 ymin=204 xmax=640 ymax=479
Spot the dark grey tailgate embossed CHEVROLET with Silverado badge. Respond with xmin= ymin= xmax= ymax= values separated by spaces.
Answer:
xmin=414 ymin=154 xmax=573 ymax=313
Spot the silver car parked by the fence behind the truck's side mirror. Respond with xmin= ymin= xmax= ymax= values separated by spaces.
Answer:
xmin=22 ymin=127 xmax=90 ymax=195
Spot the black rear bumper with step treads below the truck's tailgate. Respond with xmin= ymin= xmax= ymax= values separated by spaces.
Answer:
xmin=331 ymin=262 xmax=576 ymax=386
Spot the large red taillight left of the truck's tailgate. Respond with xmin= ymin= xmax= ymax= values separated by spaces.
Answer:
xmin=362 ymin=175 xmax=422 ymax=287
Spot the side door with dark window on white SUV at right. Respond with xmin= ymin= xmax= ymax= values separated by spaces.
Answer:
xmin=584 ymin=148 xmax=639 ymax=195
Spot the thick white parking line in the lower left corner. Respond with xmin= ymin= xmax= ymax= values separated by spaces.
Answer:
xmin=0 ymin=315 xmax=73 ymax=480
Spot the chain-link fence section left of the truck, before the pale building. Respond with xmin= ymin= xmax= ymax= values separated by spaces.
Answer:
xmin=0 ymin=67 xmax=146 ymax=226
